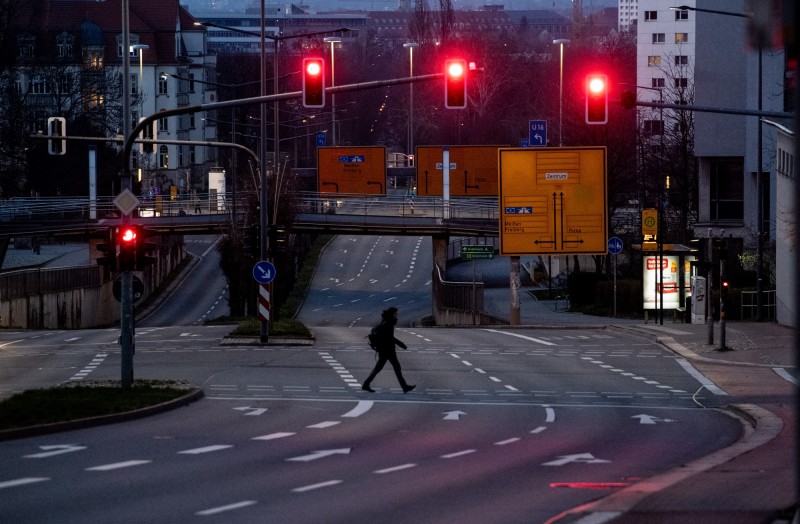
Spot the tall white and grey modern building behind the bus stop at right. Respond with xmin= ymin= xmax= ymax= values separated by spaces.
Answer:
xmin=636 ymin=0 xmax=792 ymax=324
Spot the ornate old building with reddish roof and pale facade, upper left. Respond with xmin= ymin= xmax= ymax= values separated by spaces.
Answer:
xmin=9 ymin=0 xmax=216 ymax=195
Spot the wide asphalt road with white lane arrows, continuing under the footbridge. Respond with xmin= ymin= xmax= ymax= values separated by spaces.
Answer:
xmin=0 ymin=236 xmax=742 ymax=523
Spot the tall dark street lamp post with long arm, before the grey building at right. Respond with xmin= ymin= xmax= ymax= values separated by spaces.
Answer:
xmin=670 ymin=5 xmax=764 ymax=322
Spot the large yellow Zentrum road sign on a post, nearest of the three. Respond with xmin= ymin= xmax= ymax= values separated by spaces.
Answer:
xmin=499 ymin=147 xmax=608 ymax=255
